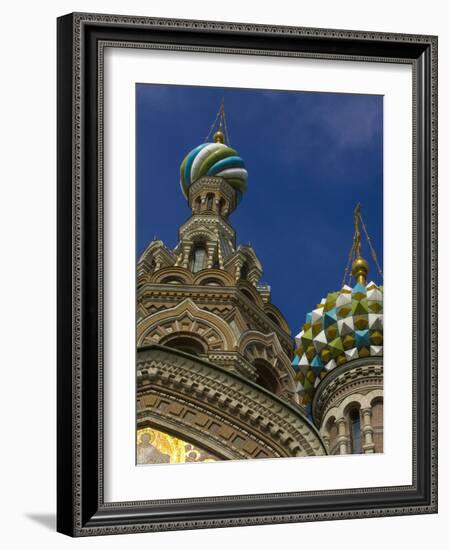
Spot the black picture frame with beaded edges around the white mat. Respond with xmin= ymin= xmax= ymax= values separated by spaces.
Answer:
xmin=57 ymin=13 xmax=437 ymax=536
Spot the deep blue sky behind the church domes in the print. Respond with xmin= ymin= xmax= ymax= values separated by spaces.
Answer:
xmin=136 ymin=84 xmax=383 ymax=335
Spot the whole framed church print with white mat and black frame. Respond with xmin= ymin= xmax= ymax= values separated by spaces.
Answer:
xmin=58 ymin=13 xmax=437 ymax=536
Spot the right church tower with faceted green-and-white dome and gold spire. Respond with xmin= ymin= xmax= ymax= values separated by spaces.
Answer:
xmin=293 ymin=205 xmax=383 ymax=454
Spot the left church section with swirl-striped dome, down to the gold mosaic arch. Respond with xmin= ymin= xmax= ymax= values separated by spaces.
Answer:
xmin=137 ymin=103 xmax=325 ymax=463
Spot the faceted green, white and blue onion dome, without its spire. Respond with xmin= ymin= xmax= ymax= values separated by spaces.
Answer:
xmin=293 ymin=282 xmax=383 ymax=411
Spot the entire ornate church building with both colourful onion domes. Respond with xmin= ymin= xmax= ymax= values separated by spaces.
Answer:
xmin=137 ymin=102 xmax=383 ymax=464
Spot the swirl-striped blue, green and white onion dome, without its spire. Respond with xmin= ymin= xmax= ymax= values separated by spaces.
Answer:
xmin=180 ymin=142 xmax=248 ymax=201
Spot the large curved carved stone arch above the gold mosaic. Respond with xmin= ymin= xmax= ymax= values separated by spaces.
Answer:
xmin=137 ymin=346 xmax=326 ymax=458
